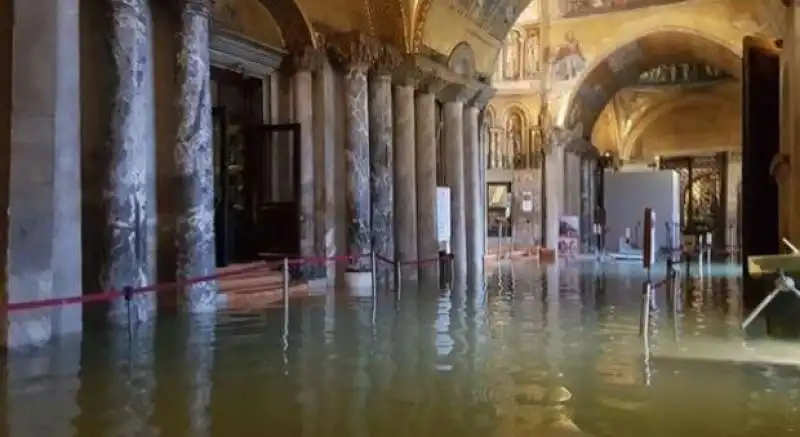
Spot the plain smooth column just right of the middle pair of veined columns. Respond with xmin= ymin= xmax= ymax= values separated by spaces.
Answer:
xmin=394 ymin=84 xmax=418 ymax=272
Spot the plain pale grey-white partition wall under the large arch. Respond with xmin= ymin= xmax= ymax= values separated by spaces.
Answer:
xmin=605 ymin=170 xmax=680 ymax=252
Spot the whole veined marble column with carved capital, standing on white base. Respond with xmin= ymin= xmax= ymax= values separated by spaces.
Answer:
xmin=330 ymin=32 xmax=374 ymax=280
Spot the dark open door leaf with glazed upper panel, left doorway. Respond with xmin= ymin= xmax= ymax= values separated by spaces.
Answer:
xmin=245 ymin=123 xmax=300 ymax=259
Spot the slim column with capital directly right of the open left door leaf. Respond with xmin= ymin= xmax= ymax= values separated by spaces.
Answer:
xmin=288 ymin=47 xmax=325 ymax=279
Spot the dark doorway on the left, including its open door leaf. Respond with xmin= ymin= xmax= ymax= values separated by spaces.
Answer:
xmin=211 ymin=68 xmax=300 ymax=266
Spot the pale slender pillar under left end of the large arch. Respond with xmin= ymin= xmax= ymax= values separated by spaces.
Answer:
xmin=544 ymin=143 xmax=566 ymax=250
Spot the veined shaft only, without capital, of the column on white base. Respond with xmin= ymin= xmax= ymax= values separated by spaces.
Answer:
xmin=345 ymin=69 xmax=371 ymax=272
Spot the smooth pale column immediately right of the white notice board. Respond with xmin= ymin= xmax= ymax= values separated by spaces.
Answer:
xmin=443 ymin=100 xmax=467 ymax=284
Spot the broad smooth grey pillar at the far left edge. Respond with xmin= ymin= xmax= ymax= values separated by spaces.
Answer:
xmin=5 ymin=0 xmax=83 ymax=346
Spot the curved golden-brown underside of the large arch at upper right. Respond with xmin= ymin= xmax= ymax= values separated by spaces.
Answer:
xmin=555 ymin=26 xmax=742 ymax=139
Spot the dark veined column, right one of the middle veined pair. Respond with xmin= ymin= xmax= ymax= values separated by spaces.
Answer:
xmin=369 ymin=46 xmax=400 ymax=279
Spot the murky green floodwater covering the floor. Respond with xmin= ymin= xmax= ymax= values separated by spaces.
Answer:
xmin=0 ymin=263 xmax=800 ymax=437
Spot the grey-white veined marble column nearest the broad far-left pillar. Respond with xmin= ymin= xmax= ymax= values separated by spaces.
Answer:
xmin=101 ymin=0 xmax=158 ymax=324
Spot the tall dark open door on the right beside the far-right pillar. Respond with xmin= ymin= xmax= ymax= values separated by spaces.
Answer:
xmin=741 ymin=36 xmax=780 ymax=308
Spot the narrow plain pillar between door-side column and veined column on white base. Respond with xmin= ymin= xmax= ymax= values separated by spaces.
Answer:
xmin=312 ymin=58 xmax=337 ymax=282
